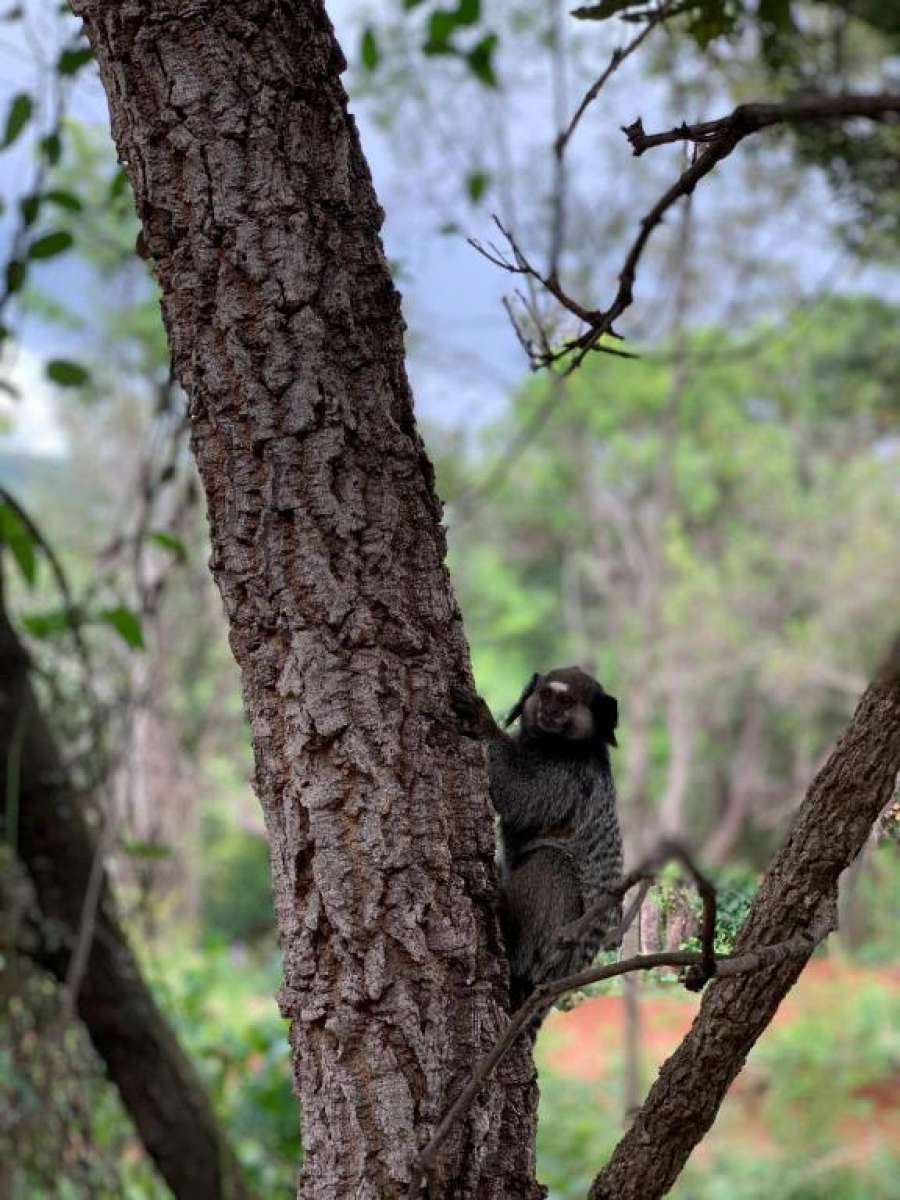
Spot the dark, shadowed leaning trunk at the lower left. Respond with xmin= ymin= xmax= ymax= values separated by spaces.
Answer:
xmin=0 ymin=566 xmax=250 ymax=1200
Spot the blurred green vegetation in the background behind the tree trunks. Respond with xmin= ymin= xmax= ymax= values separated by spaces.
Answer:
xmin=0 ymin=0 xmax=900 ymax=1200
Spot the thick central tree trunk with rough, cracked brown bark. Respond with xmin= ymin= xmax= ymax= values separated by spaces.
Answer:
xmin=73 ymin=0 xmax=540 ymax=1200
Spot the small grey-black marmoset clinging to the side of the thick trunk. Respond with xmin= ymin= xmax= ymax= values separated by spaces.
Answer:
xmin=490 ymin=667 xmax=622 ymax=1009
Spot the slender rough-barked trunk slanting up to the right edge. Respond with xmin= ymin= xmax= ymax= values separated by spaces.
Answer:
xmin=590 ymin=641 xmax=900 ymax=1200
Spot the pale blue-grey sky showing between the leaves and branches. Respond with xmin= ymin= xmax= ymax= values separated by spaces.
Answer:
xmin=0 ymin=0 xmax=900 ymax=463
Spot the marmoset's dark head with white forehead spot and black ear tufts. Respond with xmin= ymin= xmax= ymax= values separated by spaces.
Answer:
xmin=506 ymin=667 xmax=619 ymax=746
